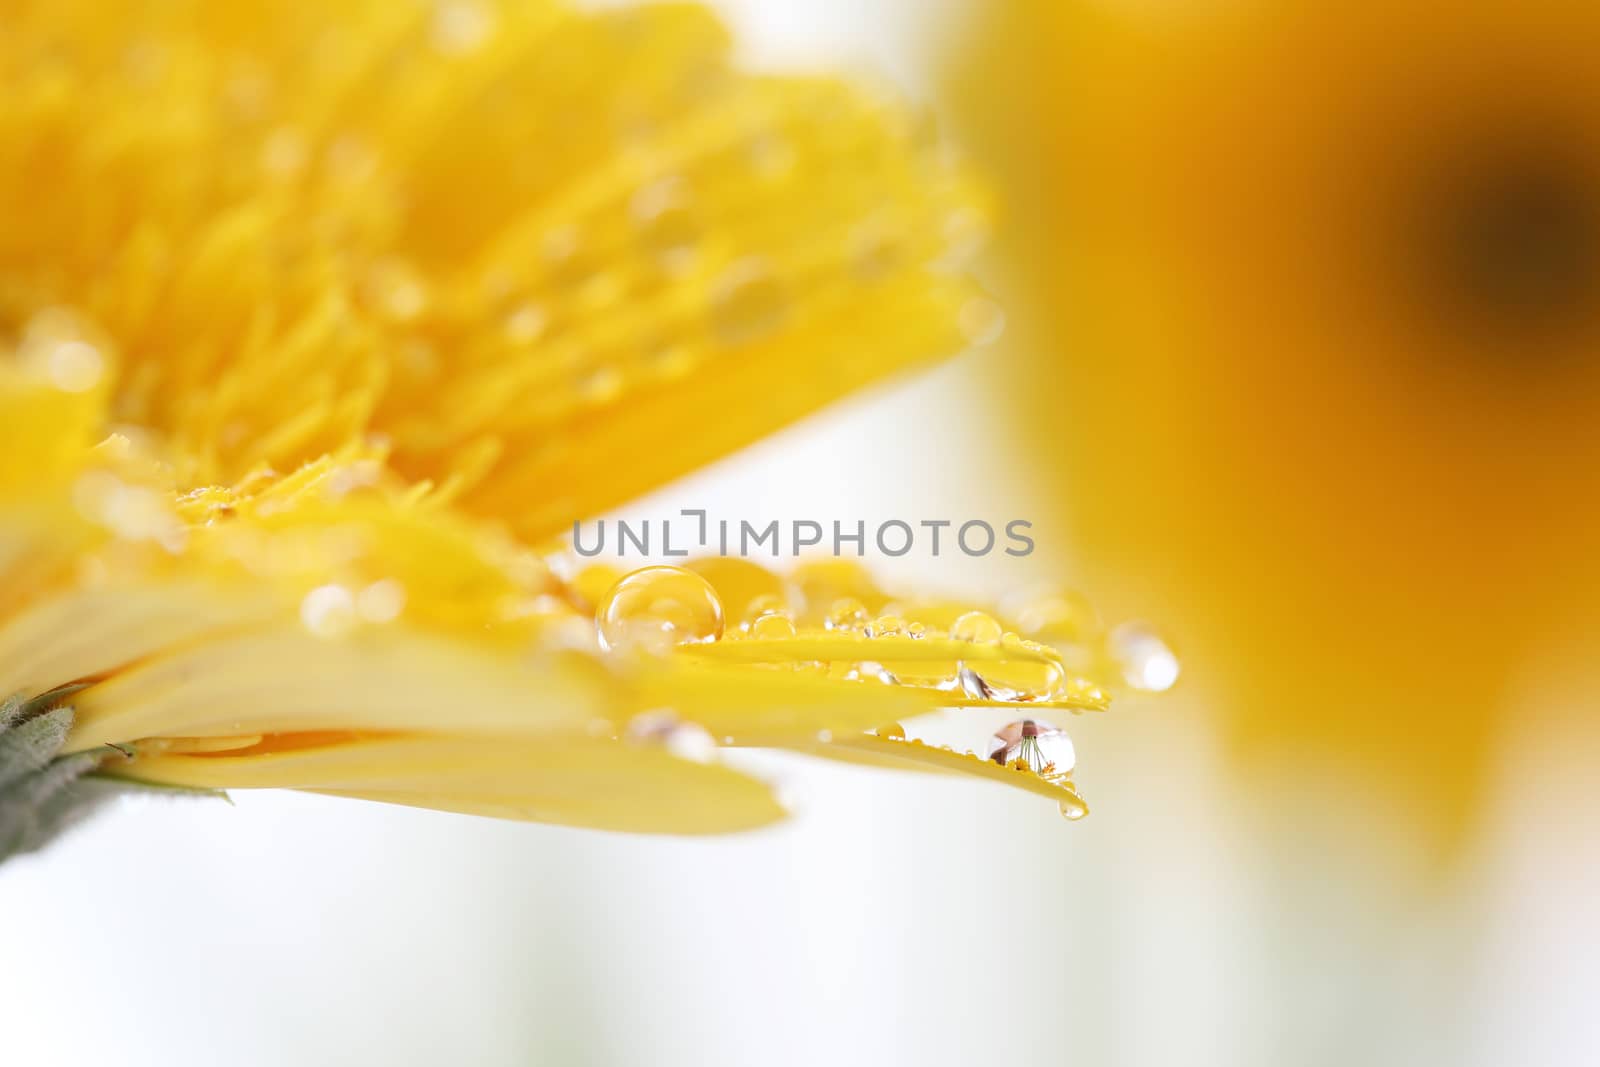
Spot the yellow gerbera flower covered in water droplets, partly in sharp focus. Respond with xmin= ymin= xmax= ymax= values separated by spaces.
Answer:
xmin=0 ymin=0 xmax=1132 ymax=854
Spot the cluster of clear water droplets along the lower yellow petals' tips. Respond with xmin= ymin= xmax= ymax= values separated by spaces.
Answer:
xmin=576 ymin=558 xmax=1158 ymax=819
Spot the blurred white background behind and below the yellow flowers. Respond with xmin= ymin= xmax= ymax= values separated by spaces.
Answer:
xmin=0 ymin=0 xmax=1600 ymax=1067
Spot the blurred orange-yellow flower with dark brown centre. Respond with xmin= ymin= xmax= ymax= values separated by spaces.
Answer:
xmin=952 ymin=0 xmax=1600 ymax=843
